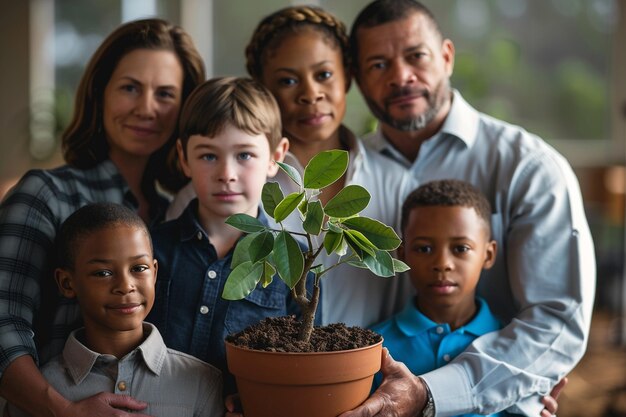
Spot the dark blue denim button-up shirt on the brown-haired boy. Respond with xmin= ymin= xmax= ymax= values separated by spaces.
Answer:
xmin=146 ymin=199 xmax=297 ymax=393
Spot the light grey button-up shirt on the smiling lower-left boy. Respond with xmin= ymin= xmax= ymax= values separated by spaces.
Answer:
xmin=9 ymin=323 xmax=224 ymax=417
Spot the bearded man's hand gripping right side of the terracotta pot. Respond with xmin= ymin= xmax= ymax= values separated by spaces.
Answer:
xmin=339 ymin=348 xmax=426 ymax=417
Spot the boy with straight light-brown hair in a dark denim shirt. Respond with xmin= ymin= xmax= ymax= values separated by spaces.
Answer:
xmin=147 ymin=77 xmax=293 ymax=394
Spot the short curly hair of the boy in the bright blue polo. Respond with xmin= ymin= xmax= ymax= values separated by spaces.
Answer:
xmin=401 ymin=179 xmax=491 ymax=234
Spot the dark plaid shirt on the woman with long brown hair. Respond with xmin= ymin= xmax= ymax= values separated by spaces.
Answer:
xmin=0 ymin=160 xmax=167 ymax=373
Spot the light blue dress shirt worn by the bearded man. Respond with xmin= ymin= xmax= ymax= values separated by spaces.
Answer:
xmin=364 ymin=91 xmax=596 ymax=417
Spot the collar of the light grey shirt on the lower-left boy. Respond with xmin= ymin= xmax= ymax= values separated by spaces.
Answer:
xmin=63 ymin=323 xmax=167 ymax=385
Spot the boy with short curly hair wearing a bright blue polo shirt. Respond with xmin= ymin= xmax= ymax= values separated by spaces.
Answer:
xmin=372 ymin=180 xmax=501 ymax=416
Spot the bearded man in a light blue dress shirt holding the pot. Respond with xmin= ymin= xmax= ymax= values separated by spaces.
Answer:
xmin=342 ymin=0 xmax=595 ymax=417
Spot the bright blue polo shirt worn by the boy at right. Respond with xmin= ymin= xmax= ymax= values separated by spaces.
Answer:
xmin=372 ymin=297 xmax=503 ymax=416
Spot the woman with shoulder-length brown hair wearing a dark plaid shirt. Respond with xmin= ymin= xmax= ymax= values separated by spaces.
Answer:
xmin=0 ymin=19 xmax=205 ymax=416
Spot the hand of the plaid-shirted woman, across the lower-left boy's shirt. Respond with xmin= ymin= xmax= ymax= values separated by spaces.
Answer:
xmin=59 ymin=392 xmax=150 ymax=417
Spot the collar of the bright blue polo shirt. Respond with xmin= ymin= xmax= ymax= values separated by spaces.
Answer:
xmin=395 ymin=297 xmax=501 ymax=337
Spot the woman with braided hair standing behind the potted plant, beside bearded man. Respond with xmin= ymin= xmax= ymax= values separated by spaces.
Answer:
xmin=246 ymin=6 xmax=415 ymax=327
